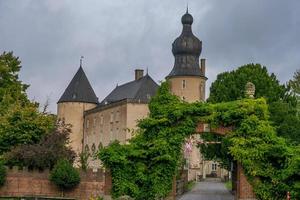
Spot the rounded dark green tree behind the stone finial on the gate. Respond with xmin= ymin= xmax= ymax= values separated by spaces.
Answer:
xmin=208 ymin=64 xmax=286 ymax=103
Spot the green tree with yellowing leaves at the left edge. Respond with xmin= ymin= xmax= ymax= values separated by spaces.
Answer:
xmin=0 ymin=52 xmax=55 ymax=155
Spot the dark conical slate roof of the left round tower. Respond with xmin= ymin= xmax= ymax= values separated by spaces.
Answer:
xmin=57 ymin=66 xmax=98 ymax=104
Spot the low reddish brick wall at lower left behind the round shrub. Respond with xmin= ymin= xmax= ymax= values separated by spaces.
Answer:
xmin=0 ymin=168 xmax=105 ymax=200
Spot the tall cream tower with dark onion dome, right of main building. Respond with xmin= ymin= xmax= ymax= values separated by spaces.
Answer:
xmin=166 ymin=10 xmax=207 ymax=102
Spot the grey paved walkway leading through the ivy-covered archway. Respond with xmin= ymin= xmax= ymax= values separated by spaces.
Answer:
xmin=179 ymin=182 xmax=234 ymax=200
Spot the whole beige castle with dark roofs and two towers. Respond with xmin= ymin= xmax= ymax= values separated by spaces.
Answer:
xmin=57 ymin=10 xmax=227 ymax=179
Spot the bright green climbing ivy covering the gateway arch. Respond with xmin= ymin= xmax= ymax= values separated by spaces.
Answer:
xmin=98 ymin=83 xmax=300 ymax=200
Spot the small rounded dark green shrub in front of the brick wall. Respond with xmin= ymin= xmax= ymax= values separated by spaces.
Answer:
xmin=50 ymin=159 xmax=80 ymax=191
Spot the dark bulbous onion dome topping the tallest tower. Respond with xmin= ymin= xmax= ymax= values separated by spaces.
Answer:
xmin=167 ymin=10 xmax=204 ymax=78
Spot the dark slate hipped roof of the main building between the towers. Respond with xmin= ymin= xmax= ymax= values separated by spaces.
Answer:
xmin=101 ymin=74 xmax=159 ymax=105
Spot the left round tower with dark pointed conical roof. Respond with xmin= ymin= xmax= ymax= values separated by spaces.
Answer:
xmin=57 ymin=64 xmax=98 ymax=154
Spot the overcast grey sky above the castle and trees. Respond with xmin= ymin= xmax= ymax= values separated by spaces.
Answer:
xmin=0 ymin=0 xmax=300 ymax=113
